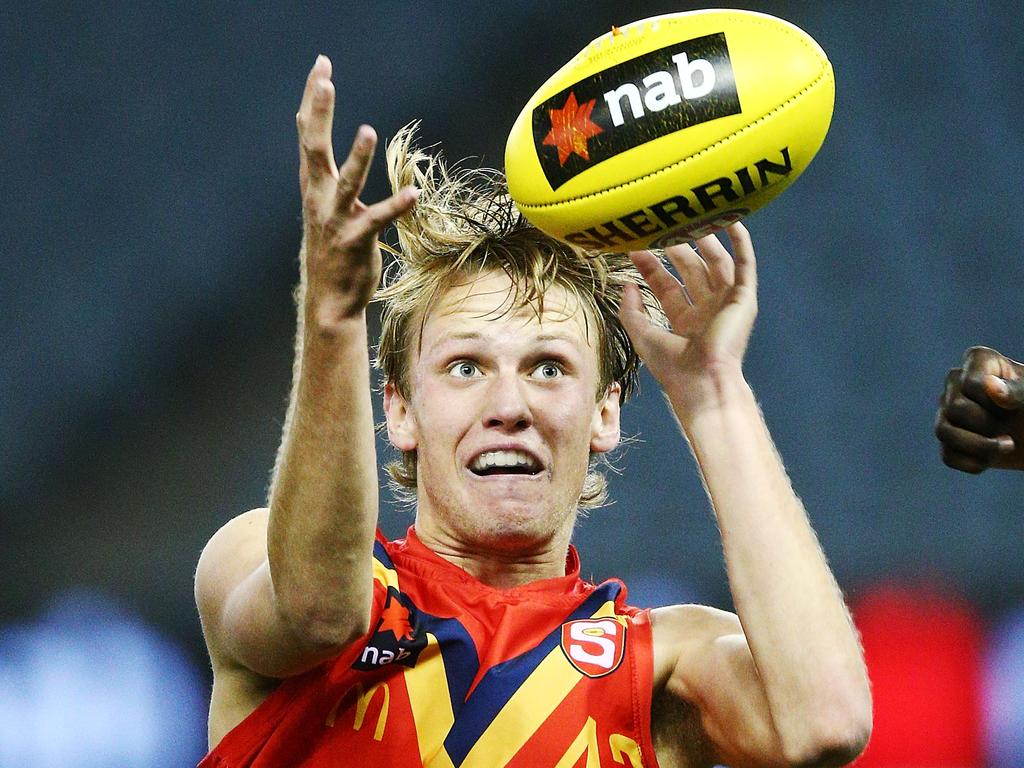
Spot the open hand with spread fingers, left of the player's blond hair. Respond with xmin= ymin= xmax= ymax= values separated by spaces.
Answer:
xmin=295 ymin=55 xmax=418 ymax=329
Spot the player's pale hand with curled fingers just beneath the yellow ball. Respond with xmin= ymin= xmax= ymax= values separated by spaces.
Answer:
xmin=621 ymin=223 xmax=758 ymax=415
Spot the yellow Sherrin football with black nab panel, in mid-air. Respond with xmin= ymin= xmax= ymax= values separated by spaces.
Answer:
xmin=505 ymin=10 xmax=836 ymax=251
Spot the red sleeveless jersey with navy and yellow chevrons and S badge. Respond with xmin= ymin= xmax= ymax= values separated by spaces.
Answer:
xmin=200 ymin=528 xmax=657 ymax=768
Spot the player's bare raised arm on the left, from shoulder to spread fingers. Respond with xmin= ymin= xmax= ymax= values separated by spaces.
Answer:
xmin=196 ymin=56 xmax=416 ymax=684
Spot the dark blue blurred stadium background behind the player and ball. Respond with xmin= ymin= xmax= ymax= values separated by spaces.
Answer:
xmin=0 ymin=0 xmax=1024 ymax=768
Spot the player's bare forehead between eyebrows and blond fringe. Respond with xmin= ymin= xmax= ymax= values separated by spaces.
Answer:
xmin=420 ymin=271 xmax=594 ymax=352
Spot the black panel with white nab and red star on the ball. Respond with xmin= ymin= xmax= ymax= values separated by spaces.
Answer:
xmin=532 ymin=33 xmax=741 ymax=189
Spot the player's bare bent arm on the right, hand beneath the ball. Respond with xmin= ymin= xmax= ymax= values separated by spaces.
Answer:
xmin=623 ymin=224 xmax=871 ymax=768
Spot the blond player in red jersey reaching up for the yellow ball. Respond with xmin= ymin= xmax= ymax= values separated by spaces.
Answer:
xmin=196 ymin=56 xmax=871 ymax=768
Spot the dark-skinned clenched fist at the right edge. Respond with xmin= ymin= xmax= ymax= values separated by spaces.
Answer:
xmin=935 ymin=347 xmax=1024 ymax=474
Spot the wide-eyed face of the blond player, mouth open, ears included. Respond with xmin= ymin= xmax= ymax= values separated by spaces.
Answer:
xmin=385 ymin=272 xmax=618 ymax=551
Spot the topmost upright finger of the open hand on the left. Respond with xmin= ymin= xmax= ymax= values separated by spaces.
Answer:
xmin=295 ymin=55 xmax=337 ymax=197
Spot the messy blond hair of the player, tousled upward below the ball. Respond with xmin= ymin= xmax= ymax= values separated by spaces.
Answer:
xmin=375 ymin=123 xmax=664 ymax=509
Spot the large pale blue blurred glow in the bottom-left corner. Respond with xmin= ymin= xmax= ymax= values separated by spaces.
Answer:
xmin=0 ymin=590 xmax=207 ymax=768
